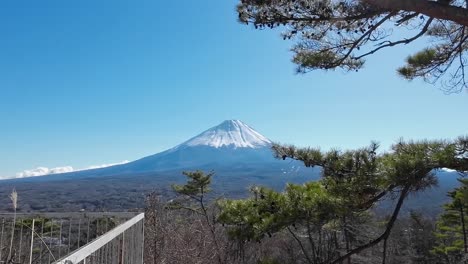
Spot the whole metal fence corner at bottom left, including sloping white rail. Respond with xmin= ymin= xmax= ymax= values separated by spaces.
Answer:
xmin=0 ymin=213 xmax=144 ymax=264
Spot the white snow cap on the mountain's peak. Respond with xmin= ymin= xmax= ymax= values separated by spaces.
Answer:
xmin=176 ymin=120 xmax=272 ymax=148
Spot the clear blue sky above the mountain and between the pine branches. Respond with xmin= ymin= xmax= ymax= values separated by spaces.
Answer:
xmin=0 ymin=0 xmax=468 ymax=177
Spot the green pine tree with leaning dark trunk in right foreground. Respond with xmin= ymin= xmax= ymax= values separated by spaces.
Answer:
xmin=218 ymin=137 xmax=468 ymax=263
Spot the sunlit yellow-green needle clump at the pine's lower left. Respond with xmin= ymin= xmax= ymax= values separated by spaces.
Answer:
xmin=218 ymin=182 xmax=339 ymax=240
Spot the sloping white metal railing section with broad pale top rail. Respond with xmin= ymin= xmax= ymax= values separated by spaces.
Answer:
xmin=55 ymin=213 xmax=145 ymax=264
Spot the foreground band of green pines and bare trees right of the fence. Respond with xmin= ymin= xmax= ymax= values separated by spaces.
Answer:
xmin=145 ymin=137 xmax=468 ymax=264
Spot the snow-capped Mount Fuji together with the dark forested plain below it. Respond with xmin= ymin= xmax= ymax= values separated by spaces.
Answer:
xmin=0 ymin=120 xmax=320 ymax=211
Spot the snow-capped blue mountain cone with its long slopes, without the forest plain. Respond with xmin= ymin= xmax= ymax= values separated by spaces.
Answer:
xmin=14 ymin=120 xmax=310 ymax=180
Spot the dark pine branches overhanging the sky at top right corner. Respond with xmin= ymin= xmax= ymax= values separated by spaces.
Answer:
xmin=237 ymin=0 xmax=468 ymax=92
